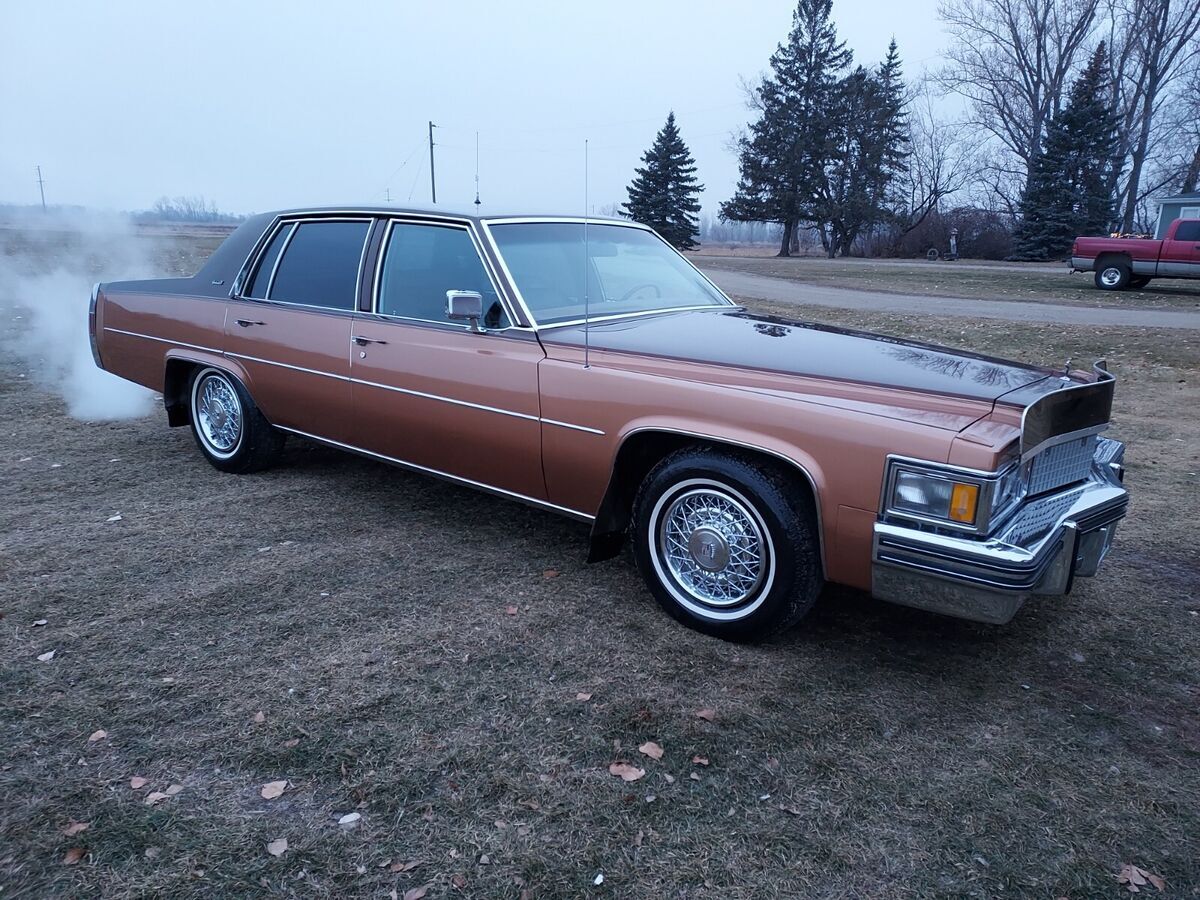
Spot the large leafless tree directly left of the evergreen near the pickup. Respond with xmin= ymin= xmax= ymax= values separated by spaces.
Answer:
xmin=936 ymin=0 xmax=1104 ymax=209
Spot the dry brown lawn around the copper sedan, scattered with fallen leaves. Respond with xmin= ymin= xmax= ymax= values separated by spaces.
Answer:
xmin=0 ymin=230 xmax=1200 ymax=898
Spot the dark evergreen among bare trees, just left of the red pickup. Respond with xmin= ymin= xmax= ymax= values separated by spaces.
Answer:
xmin=1013 ymin=42 xmax=1117 ymax=259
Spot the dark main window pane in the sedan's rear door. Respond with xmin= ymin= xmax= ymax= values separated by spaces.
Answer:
xmin=270 ymin=222 xmax=370 ymax=310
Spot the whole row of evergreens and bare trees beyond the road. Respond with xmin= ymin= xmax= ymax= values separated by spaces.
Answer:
xmin=622 ymin=0 xmax=1200 ymax=259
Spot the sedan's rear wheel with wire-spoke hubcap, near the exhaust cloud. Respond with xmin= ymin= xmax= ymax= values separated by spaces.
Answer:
xmin=188 ymin=367 xmax=283 ymax=473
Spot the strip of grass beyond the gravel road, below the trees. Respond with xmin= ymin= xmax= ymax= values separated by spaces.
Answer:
xmin=695 ymin=256 xmax=1200 ymax=310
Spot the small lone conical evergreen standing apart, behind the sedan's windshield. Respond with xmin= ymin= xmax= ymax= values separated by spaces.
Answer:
xmin=624 ymin=113 xmax=704 ymax=250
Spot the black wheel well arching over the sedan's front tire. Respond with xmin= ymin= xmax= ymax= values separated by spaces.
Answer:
xmin=588 ymin=431 xmax=821 ymax=563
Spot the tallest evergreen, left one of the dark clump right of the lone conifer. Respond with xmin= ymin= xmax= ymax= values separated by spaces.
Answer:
xmin=721 ymin=0 xmax=851 ymax=257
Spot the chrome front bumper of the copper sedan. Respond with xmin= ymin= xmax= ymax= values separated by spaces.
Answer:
xmin=871 ymin=438 xmax=1129 ymax=625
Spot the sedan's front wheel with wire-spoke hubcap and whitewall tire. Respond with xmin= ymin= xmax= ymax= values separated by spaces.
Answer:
xmin=634 ymin=449 xmax=822 ymax=641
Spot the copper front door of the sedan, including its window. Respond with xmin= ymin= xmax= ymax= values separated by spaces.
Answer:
xmin=350 ymin=220 xmax=546 ymax=500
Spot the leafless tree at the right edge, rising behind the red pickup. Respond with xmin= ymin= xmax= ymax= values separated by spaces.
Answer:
xmin=1109 ymin=0 xmax=1200 ymax=232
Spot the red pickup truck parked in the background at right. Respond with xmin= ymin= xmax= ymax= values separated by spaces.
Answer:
xmin=1070 ymin=218 xmax=1200 ymax=290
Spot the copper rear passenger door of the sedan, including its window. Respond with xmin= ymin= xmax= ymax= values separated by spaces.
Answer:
xmin=226 ymin=217 xmax=372 ymax=443
